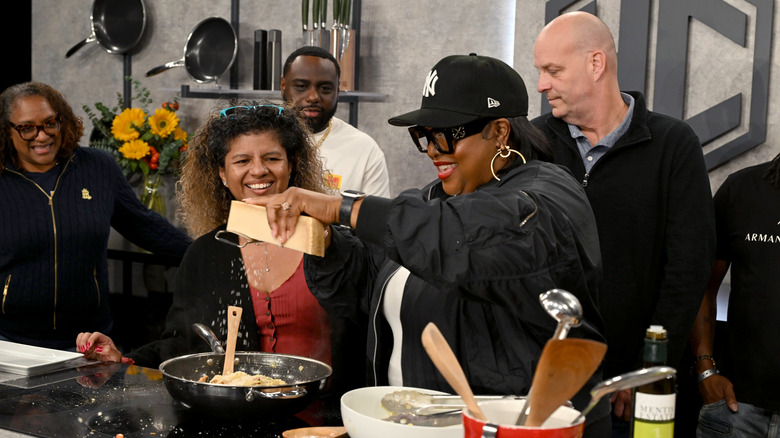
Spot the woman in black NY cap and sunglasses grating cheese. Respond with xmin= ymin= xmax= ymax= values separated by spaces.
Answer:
xmin=247 ymin=55 xmax=611 ymax=436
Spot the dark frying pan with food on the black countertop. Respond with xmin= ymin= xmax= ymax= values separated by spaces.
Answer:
xmin=160 ymin=324 xmax=333 ymax=419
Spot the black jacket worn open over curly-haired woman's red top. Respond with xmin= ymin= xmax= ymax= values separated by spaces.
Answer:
xmin=127 ymin=225 xmax=366 ymax=394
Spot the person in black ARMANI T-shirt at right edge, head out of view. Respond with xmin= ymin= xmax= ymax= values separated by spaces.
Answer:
xmin=691 ymin=154 xmax=780 ymax=438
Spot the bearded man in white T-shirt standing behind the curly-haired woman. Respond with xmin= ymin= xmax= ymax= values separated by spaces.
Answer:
xmin=281 ymin=46 xmax=390 ymax=197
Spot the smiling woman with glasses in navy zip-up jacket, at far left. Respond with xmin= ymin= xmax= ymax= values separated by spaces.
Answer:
xmin=0 ymin=82 xmax=190 ymax=349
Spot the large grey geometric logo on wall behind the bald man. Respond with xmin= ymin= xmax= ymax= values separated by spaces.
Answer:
xmin=542 ymin=0 xmax=774 ymax=170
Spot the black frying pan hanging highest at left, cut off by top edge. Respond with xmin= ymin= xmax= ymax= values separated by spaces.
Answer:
xmin=65 ymin=0 xmax=146 ymax=58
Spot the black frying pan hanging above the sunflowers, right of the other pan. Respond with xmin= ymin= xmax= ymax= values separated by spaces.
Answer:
xmin=146 ymin=17 xmax=238 ymax=83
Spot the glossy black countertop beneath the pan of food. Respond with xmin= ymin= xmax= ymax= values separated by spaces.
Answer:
xmin=0 ymin=364 xmax=341 ymax=438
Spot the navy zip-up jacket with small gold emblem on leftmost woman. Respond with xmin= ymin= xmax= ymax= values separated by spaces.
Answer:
xmin=0 ymin=147 xmax=190 ymax=348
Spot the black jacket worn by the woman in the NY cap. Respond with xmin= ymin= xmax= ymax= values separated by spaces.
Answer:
xmin=304 ymin=161 xmax=609 ymax=419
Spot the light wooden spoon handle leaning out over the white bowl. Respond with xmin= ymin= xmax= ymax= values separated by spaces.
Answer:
xmin=422 ymin=322 xmax=487 ymax=422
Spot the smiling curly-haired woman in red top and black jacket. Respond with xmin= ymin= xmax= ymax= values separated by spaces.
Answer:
xmin=77 ymin=102 xmax=365 ymax=393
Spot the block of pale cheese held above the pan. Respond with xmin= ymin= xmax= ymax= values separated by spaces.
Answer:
xmin=227 ymin=201 xmax=325 ymax=257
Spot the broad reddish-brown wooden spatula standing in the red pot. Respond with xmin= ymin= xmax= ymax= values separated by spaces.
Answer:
xmin=525 ymin=338 xmax=607 ymax=427
